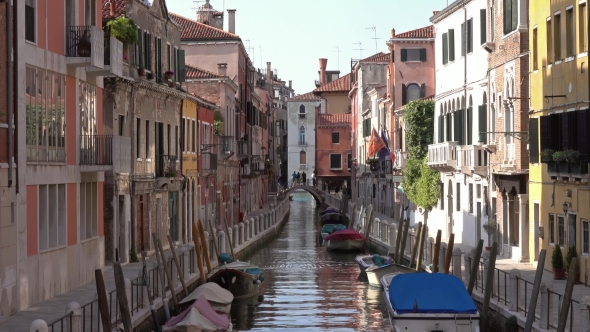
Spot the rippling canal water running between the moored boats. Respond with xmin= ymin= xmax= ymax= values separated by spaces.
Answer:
xmin=231 ymin=191 xmax=389 ymax=331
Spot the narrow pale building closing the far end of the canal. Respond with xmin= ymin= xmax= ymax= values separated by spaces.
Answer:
xmin=287 ymin=92 xmax=320 ymax=181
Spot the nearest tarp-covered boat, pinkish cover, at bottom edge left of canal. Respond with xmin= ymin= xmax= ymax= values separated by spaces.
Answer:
xmin=162 ymin=295 xmax=232 ymax=332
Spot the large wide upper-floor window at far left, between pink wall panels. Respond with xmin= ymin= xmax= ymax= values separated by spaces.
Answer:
xmin=25 ymin=67 xmax=67 ymax=162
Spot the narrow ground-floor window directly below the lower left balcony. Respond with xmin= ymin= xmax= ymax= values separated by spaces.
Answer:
xmin=79 ymin=182 xmax=98 ymax=240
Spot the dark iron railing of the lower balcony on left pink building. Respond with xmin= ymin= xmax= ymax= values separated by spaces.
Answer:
xmin=80 ymin=135 xmax=113 ymax=165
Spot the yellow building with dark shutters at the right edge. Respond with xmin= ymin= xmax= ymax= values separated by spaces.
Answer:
xmin=522 ymin=0 xmax=590 ymax=280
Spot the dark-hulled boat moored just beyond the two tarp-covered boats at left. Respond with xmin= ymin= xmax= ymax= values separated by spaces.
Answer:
xmin=207 ymin=261 xmax=264 ymax=300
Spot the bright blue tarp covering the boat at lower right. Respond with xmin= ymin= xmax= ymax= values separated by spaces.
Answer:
xmin=389 ymin=273 xmax=477 ymax=314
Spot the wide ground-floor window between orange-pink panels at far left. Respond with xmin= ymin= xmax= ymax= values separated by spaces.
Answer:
xmin=38 ymin=184 xmax=67 ymax=250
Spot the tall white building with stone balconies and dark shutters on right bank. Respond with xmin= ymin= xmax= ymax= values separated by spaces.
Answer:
xmin=428 ymin=0 xmax=491 ymax=246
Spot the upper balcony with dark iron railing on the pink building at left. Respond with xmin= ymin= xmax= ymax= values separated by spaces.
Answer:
xmin=66 ymin=26 xmax=105 ymax=69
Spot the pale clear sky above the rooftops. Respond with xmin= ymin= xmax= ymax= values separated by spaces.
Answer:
xmin=166 ymin=0 xmax=454 ymax=94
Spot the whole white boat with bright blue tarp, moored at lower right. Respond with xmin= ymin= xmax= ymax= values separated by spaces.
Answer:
xmin=383 ymin=273 xmax=480 ymax=332
